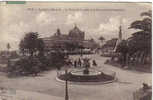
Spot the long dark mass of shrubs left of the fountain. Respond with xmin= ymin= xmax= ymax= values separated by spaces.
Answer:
xmin=8 ymin=52 xmax=66 ymax=75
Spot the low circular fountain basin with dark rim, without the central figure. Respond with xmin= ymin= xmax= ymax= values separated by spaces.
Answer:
xmin=58 ymin=68 xmax=115 ymax=83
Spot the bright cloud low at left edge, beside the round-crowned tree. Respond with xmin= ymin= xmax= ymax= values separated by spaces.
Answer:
xmin=0 ymin=21 xmax=29 ymax=50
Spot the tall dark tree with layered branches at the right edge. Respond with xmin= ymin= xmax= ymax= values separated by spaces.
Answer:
xmin=128 ymin=10 xmax=152 ymax=63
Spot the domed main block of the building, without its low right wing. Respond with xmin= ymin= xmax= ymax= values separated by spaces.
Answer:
xmin=43 ymin=26 xmax=85 ymax=50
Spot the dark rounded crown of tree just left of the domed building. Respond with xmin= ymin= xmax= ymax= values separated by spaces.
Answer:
xmin=19 ymin=32 xmax=45 ymax=56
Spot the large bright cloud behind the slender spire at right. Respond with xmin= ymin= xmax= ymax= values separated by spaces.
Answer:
xmin=90 ymin=16 xmax=129 ymax=39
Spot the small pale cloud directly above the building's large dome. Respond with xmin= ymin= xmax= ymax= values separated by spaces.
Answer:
xmin=66 ymin=12 xmax=82 ymax=24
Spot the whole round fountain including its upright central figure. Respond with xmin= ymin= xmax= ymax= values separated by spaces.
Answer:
xmin=58 ymin=57 xmax=115 ymax=83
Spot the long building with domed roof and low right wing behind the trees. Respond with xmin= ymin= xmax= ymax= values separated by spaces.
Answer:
xmin=43 ymin=25 xmax=95 ymax=51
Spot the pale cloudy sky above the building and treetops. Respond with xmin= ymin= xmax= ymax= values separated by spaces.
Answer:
xmin=0 ymin=2 xmax=152 ymax=50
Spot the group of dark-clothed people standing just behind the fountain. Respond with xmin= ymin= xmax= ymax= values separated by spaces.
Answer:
xmin=67 ymin=57 xmax=97 ymax=68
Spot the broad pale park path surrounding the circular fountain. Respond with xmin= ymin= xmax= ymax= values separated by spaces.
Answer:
xmin=0 ymin=55 xmax=151 ymax=100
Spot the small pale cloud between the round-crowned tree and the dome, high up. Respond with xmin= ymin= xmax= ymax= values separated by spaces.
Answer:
xmin=36 ymin=12 xmax=56 ymax=25
